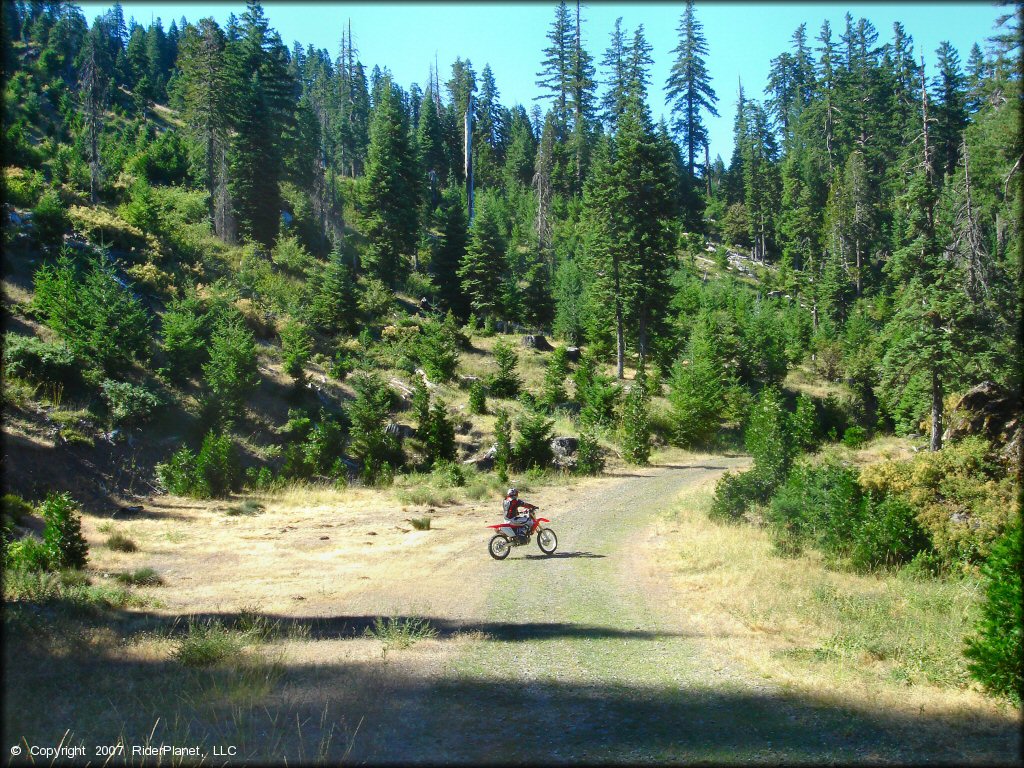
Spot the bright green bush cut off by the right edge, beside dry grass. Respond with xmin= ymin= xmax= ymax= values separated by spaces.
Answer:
xmin=964 ymin=525 xmax=1024 ymax=706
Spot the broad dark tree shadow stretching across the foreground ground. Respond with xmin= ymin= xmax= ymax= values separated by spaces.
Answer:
xmin=3 ymin=606 xmax=1020 ymax=765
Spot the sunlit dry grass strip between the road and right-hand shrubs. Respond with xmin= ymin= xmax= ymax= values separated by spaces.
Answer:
xmin=659 ymin=473 xmax=999 ymax=712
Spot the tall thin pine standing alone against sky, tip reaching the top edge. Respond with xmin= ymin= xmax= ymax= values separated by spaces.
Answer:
xmin=665 ymin=0 xmax=718 ymax=176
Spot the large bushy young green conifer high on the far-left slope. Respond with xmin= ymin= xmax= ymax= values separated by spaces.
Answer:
xmin=34 ymin=253 xmax=150 ymax=370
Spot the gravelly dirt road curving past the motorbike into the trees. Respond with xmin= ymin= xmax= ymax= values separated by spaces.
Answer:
xmin=315 ymin=457 xmax=1017 ymax=764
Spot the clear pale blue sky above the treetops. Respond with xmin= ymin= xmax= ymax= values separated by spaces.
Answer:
xmin=80 ymin=0 xmax=1005 ymax=163
